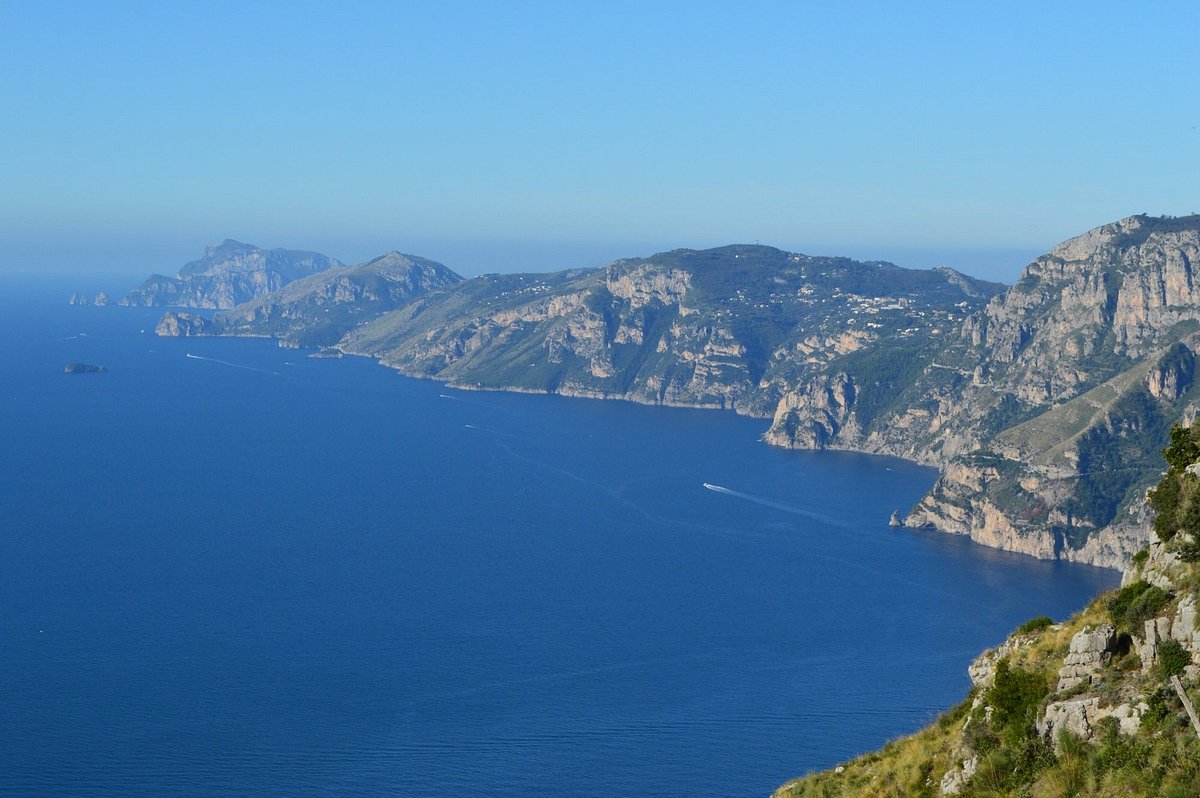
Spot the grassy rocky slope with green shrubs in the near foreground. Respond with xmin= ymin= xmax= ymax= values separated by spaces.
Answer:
xmin=776 ymin=425 xmax=1200 ymax=798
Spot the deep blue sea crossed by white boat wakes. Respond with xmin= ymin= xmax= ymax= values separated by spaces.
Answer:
xmin=0 ymin=277 xmax=1117 ymax=797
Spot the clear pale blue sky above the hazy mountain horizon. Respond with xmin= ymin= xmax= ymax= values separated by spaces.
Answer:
xmin=0 ymin=0 xmax=1200 ymax=280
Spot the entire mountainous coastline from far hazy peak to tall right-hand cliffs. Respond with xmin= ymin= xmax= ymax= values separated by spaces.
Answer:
xmin=121 ymin=216 xmax=1200 ymax=566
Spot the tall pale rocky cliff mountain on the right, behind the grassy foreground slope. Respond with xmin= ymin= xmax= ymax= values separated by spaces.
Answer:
xmin=767 ymin=216 xmax=1200 ymax=566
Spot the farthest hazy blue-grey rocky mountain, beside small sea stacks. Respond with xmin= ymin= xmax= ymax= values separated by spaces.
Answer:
xmin=119 ymin=240 xmax=342 ymax=308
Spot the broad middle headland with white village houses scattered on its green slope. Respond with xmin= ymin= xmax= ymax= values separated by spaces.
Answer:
xmin=338 ymin=246 xmax=1000 ymax=418
